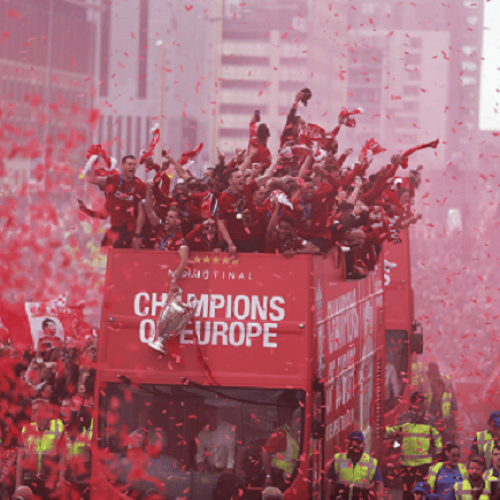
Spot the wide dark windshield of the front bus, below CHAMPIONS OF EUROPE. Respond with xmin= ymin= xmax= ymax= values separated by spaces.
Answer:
xmin=98 ymin=383 xmax=305 ymax=500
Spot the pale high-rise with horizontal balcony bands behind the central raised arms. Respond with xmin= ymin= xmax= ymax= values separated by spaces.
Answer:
xmin=210 ymin=0 xmax=311 ymax=158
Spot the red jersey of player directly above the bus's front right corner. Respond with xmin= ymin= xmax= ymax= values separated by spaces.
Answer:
xmin=293 ymin=182 xmax=335 ymax=240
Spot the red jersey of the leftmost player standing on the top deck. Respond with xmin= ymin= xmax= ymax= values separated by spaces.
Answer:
xmin=105 ymin=175 xmax=146 ymax=231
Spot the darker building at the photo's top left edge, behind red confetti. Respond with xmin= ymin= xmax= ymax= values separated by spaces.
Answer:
xmin=0 ymin=0 xmax=93 ymax=194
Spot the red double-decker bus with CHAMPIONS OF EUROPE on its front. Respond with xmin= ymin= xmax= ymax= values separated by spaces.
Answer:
xmin=92 ymin=250 xmax=387 ymax=500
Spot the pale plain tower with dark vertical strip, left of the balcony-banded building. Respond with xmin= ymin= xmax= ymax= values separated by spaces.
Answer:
xmin=95 ymin=0 xmax=210 ymax=176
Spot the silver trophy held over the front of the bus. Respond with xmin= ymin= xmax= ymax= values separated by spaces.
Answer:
xmin=149 ymin=288 xmax=198 ymax=354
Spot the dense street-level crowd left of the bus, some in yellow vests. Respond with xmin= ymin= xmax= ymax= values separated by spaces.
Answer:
xmin=0 ymin=328 xmax=95 ymax=500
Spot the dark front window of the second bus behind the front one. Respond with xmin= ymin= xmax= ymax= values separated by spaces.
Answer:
xmin=385 ymin=330 xmax=408 ymax=411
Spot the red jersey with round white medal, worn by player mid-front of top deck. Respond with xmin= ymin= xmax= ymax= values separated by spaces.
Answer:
xmin=217 ymin=181 xmax=258 ymax=241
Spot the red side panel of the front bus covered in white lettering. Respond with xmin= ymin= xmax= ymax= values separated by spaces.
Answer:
xmin=315 ymin=254 xmax=384 ymax=484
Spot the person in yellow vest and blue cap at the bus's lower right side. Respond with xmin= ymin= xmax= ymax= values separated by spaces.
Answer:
xmin=326 ymin=431 xmax=384 ymax=500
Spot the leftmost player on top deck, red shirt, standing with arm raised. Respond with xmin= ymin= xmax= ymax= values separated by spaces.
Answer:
xmin=87 ymin=155 xmax=146 ymax=249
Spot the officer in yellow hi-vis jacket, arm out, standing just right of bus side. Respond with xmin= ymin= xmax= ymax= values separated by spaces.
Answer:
xmin=386 ymin=392 xmax=443 ymax=500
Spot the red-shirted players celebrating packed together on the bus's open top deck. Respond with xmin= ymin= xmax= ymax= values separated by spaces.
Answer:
xmin=79 ymin=89 xmax=430 ymax=286
